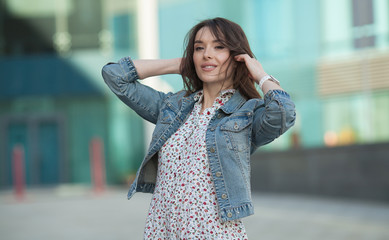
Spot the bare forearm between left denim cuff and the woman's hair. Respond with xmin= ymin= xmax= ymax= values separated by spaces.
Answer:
xmin=133 ymin=58 xmax=182 ymax=79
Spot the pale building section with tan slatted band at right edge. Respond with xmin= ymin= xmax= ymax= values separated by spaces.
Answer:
xmin=317 ymin=0 xmax=389 ymax=146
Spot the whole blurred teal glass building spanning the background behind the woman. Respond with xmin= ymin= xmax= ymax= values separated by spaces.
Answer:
xmin=0 ymin=0 xmax=389 ymax=186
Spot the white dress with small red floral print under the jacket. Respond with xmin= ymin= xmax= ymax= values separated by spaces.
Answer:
xmin=144 ymin=89 xmax=247 ymax=240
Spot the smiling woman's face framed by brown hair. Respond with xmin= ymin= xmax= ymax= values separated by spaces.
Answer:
xmin=193 ymin=27 xmax=232 ymax=89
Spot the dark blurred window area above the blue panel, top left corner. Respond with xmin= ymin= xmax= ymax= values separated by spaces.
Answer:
xmin=0 ymin=0 xmax=103 ymax=55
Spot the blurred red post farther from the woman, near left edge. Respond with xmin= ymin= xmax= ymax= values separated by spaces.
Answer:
xmin=12 ymin=145 xmax=26 ymax=200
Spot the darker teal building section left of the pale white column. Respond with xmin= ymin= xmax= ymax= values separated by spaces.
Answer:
xmin=0 ymin=0 xmax=144 ymax=187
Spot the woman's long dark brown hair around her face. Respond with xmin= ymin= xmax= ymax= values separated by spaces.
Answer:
xmin=180 ymin=18 xmax=261 ymax=99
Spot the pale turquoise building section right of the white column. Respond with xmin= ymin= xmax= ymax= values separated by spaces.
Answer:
xmin=155 ymin=0 xmax=389 ymax=149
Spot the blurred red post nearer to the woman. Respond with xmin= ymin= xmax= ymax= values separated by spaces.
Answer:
xmin=89 ymin=138 xmax=106 ymax=193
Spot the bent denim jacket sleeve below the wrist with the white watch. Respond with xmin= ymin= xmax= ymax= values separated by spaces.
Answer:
xmin=252 ymin=90 xmax=296 ymax=148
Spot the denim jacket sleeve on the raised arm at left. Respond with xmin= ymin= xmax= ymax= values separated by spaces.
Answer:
xmin=102 ymin=57 xmax=169 ymax=124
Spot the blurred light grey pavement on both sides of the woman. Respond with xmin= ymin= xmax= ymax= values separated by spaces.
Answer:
xmin=0 ymin=186 xmax=389 ymax=240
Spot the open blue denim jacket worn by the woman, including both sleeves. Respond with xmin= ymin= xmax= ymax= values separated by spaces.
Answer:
xmin=102 ymin=57 xmax=295 ymax=221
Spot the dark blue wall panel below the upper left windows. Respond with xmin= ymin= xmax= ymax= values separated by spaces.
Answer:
xmin=0 ymin=55 xmax=102 ymax=99
